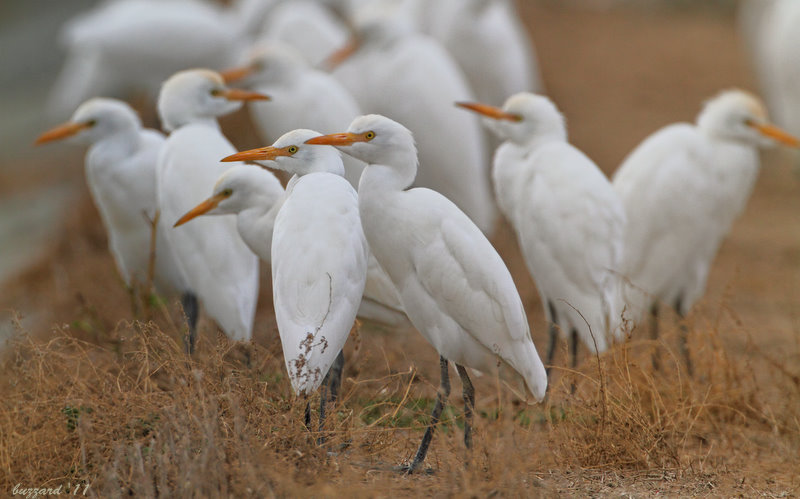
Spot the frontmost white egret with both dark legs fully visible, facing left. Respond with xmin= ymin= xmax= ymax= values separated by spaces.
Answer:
xmin=306 ymin=115 xmax=547 ymax=472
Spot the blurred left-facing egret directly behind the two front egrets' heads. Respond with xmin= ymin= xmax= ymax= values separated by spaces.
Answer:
xmin=222 ymin=42 xmax=364 ymax=187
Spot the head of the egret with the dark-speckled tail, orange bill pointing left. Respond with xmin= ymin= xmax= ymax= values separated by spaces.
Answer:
xmin=222 ymin=129 xmax=344 ymax=176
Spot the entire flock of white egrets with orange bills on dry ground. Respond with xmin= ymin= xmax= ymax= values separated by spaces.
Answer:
xmin=32 ymin=0 xmax=800 ymax=471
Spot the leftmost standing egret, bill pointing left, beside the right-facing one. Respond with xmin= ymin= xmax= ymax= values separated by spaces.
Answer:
xmin=36 ymin=98 xmax=186 ymax=298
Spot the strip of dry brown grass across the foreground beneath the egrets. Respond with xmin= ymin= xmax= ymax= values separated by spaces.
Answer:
xmin=0 ymin=292 xmax=800 ymax=497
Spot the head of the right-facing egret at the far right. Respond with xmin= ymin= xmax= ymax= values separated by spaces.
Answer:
xmin=697 ymin=90 xmax=800 ymax=147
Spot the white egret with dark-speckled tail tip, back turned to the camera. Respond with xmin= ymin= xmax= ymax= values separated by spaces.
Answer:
xmin=223 ymin=129 xmax=369 ymax=432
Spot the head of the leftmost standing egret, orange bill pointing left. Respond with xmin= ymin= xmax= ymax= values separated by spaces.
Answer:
xmin=36 ymin=97 xmax=142 ymax=144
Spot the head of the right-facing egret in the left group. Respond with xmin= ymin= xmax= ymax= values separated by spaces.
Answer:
xmin=158 ymin=69 xmax=269 ymax=131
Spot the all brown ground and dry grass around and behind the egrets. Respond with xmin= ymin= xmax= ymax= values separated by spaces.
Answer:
xmin=0 ymin=1 xmax=800 ymax=497
